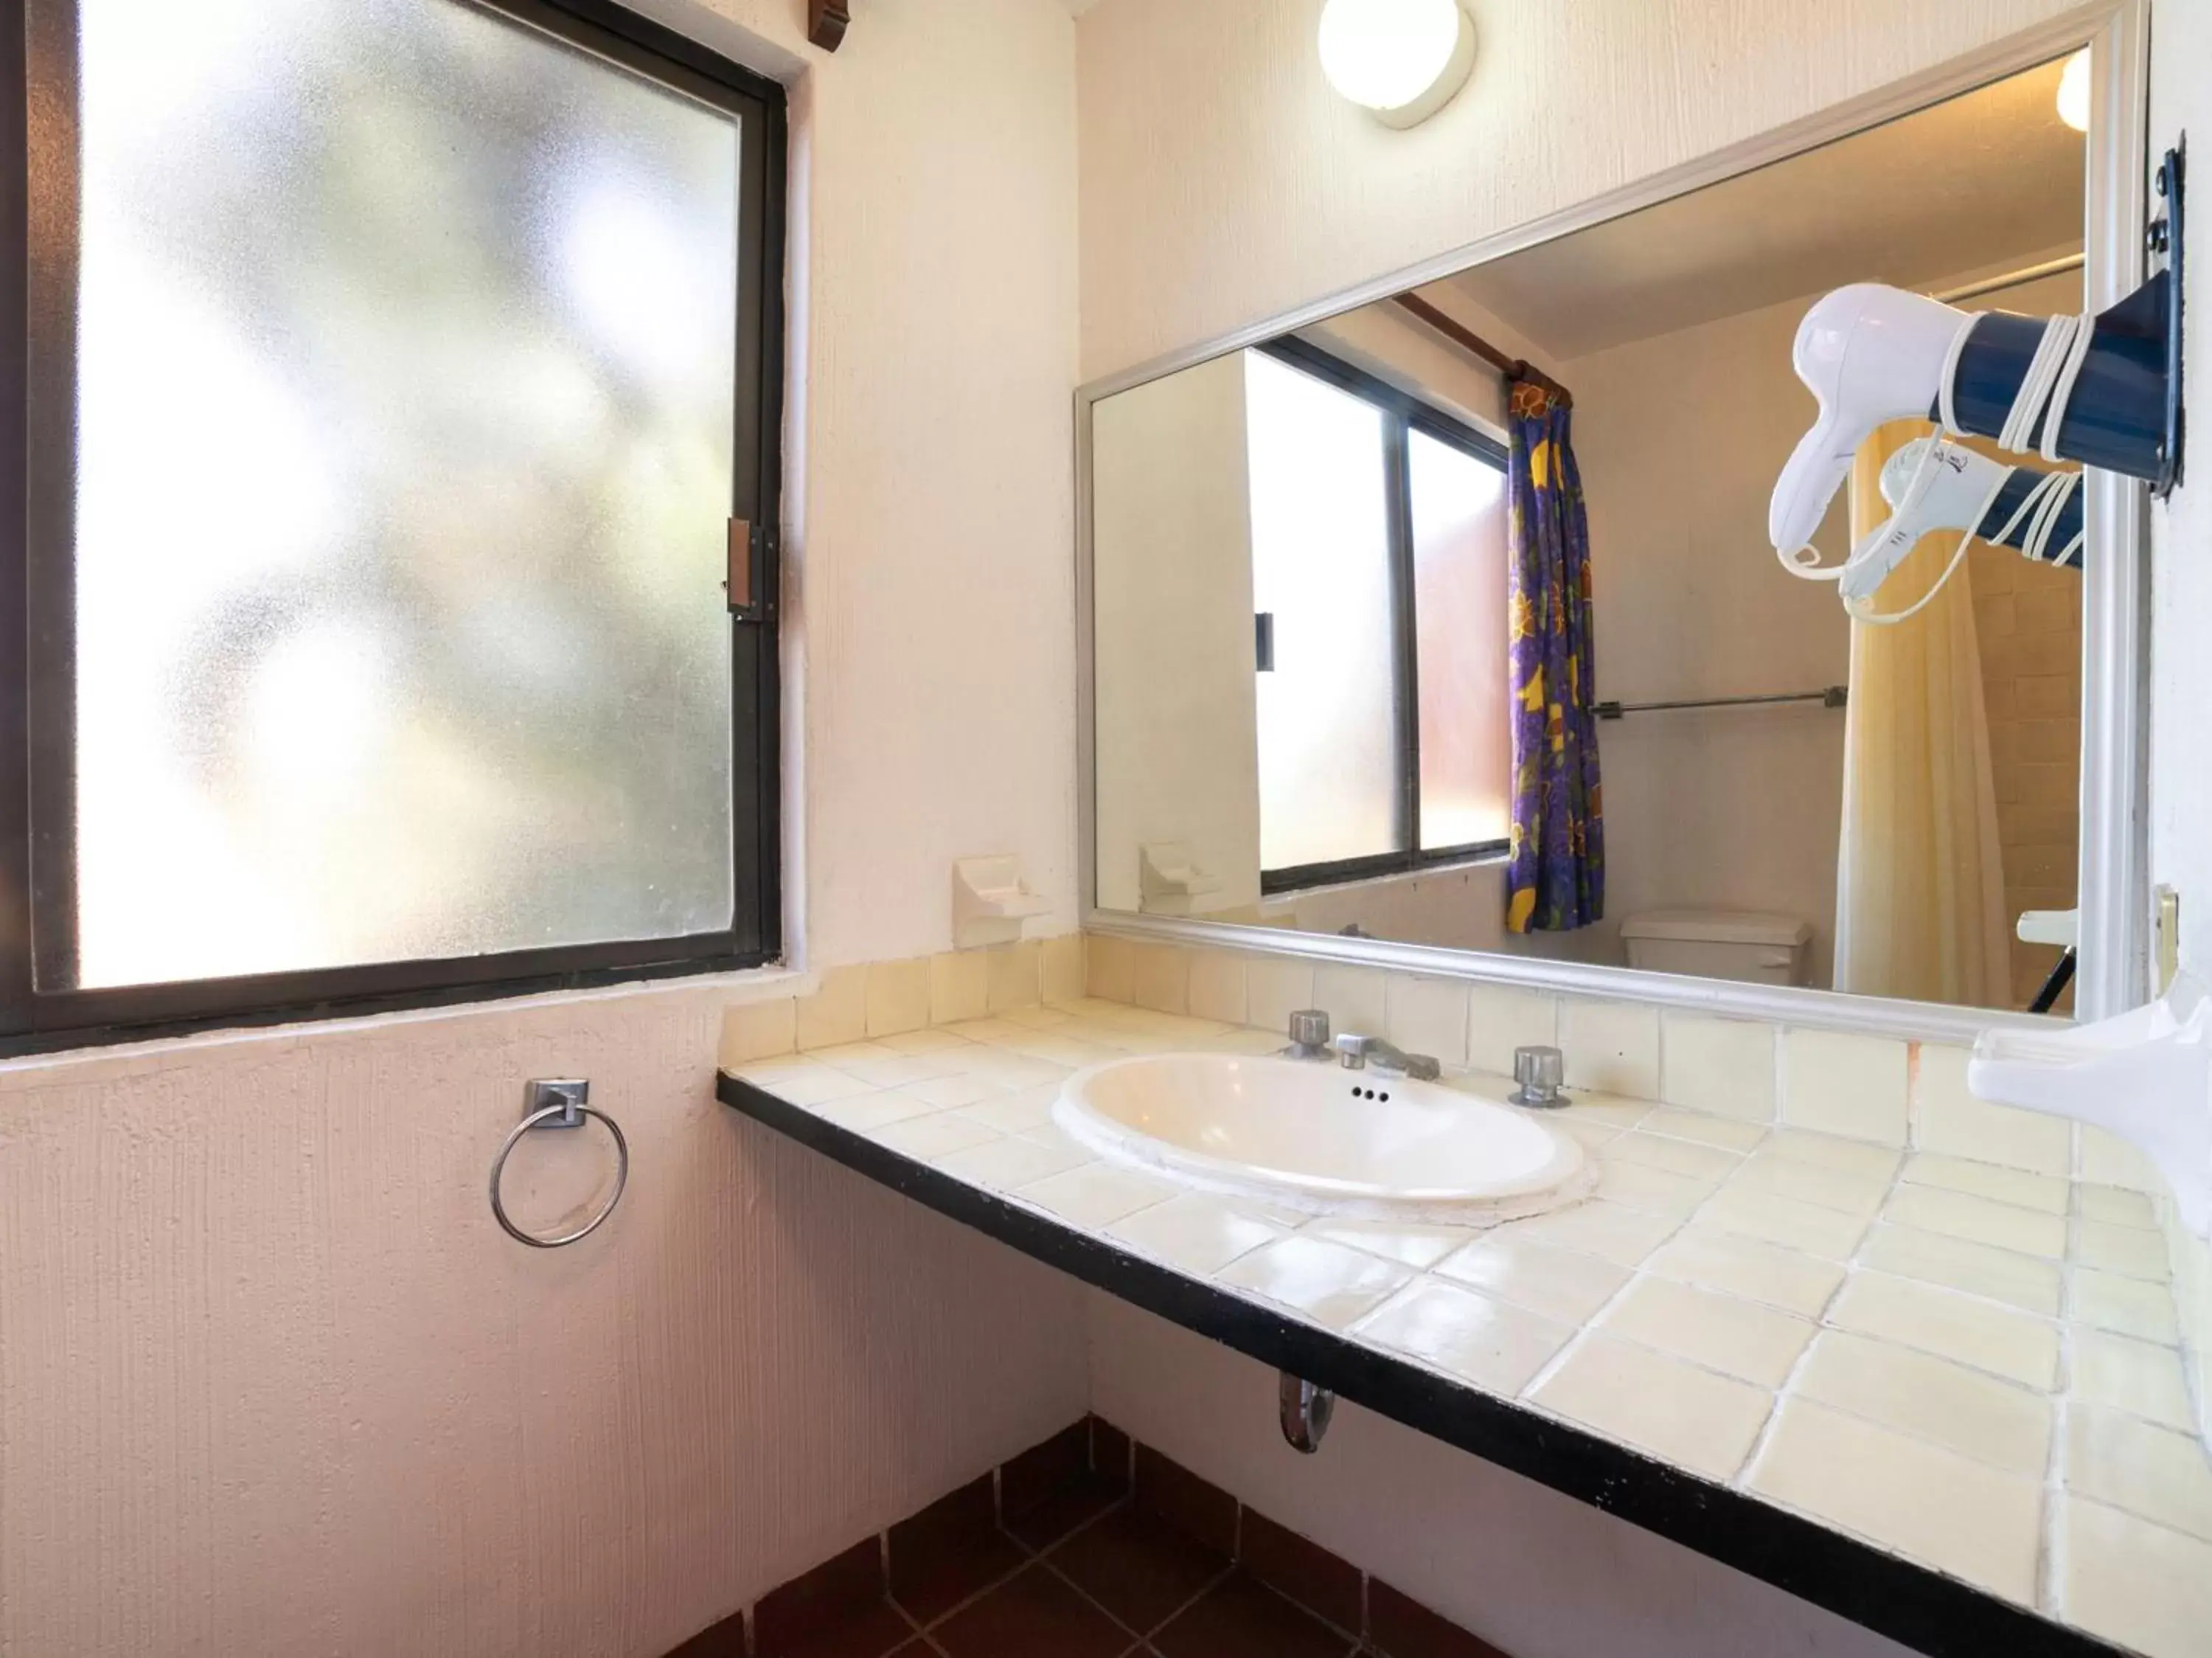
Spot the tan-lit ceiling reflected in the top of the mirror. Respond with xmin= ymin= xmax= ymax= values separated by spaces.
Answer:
xmin=1438 ymin=64 xmax=2086 ymax=361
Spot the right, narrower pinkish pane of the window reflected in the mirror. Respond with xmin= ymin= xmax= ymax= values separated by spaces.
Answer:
xmin=1407 ymin=429 xmax=1513 ymax=853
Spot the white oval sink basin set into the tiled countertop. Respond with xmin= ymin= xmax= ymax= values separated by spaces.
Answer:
xmin=1053 ymin=1054 xmax=1593 ymax=1224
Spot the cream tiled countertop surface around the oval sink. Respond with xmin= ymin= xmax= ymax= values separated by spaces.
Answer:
xmin=734 ymin=1001 xmax=2212 ymax=1658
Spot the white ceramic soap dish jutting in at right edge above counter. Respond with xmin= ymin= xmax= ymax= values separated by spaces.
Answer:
xmin=1966 ymin=974 xmax=2212 ymax=1240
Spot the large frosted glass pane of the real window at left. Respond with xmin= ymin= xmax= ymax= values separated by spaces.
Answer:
xmin=49 ymin=0 xmax=739 ymax=988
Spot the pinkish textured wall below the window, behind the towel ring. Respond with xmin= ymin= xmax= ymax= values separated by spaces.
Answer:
xmin=0 ymin=988 xmax=1088 ymax=1658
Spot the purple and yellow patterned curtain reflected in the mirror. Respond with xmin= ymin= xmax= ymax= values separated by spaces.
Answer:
xmin=1506 ymin=381 xmax=1606 ymax=932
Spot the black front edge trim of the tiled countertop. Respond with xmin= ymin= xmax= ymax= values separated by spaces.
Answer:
xmin=714 ymin=1074 xmax=2126 ymax=1658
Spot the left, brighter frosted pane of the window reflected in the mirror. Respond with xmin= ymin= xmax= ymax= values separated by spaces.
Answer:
xmin=1245 ymin=352 xmax=1398 ymax=870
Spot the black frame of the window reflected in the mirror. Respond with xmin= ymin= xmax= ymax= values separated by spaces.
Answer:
xmin=1254 ymin=334 xmax=1511 ymax=897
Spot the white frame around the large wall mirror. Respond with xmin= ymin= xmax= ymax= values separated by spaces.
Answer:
xmin=1075 ymin=0 xmax=2150 ymax=1043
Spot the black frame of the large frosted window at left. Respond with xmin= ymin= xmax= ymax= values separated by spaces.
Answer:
xmin=0 ymin=0 xmax=787 ymax=1054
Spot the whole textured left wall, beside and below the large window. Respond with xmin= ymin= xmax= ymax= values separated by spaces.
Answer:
xmin=0 ymin=0 xmax=1086 ymax=1658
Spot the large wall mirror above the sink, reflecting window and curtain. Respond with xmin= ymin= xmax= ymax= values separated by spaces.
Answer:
xmin=1084 ymin=26 xmax=2141 ymax=1016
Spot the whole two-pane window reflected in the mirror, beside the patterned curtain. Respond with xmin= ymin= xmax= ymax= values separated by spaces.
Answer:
xmin=1245 ymin=341 xmax=1511 ymax=892
